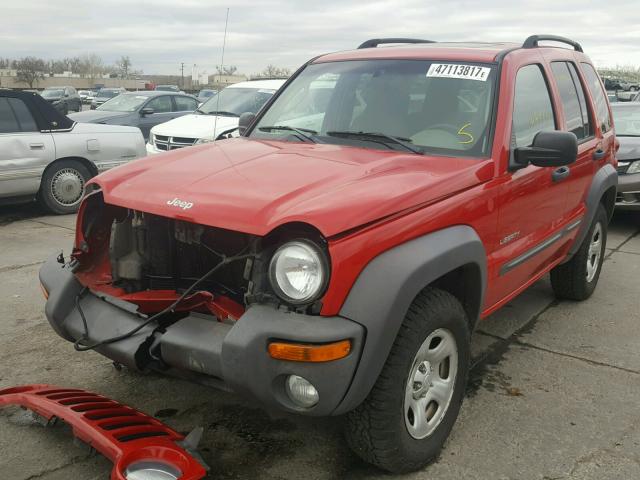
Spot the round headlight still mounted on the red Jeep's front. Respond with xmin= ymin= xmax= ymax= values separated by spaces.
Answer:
xmin=269 ymin=240 xmax=327 ymax=304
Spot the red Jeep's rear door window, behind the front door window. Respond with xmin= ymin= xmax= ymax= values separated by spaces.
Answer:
xmin=551 ymin=62 xmax=590 ymax=140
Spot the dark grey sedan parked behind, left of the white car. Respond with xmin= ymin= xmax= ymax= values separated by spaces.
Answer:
xmin=69 ymin=91 xmax=198 ymax=141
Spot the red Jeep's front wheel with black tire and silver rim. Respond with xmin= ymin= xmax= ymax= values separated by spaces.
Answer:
xmin=345 ymin=287 xmax=470 ymax=473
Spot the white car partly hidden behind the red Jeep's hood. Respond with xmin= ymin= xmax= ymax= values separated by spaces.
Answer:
xmin=147 ymin=80 xmax=285 ymax=154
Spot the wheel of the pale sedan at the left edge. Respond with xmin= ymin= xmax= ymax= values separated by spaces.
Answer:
xmin=38 ymin=160 xmax=92 ymax=215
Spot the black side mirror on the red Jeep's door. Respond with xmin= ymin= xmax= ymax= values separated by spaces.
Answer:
xmin=511 ymin=131 xmax=578 ymax=169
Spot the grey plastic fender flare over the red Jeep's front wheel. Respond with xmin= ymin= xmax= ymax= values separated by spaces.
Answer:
xmin=333 ymin=225 xmax=487 ymax=415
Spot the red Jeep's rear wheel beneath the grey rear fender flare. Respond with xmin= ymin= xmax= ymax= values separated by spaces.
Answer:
xmin=551 ymin=204 xmax=608 ymax=300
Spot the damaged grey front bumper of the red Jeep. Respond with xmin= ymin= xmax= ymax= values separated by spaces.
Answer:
xmin=40 ymin=258 xmax=364 ymax=416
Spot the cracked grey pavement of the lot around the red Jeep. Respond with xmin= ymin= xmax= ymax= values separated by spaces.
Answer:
xmin=0 ymin=206 xmax=640 ymax=480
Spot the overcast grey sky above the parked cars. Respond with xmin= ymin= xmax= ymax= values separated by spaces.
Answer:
xmin=0 ymin=0 xmax=640 ymax=75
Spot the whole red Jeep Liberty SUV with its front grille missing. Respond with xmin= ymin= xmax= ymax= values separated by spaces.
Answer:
xmin=40 ymin=35 xmax=617 ymax=472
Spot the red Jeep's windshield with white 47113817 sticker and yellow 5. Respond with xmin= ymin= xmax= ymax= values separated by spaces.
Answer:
xmin=251 ymin=60 xmax=496 ymax=156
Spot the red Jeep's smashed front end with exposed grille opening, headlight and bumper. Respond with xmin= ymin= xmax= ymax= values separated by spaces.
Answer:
xmin=40 ymin=190 xmax=364 ymax=415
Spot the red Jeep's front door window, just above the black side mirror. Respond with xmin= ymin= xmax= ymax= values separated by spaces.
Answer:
xmin=511 ymin=65 xmax=556 ymax=147
